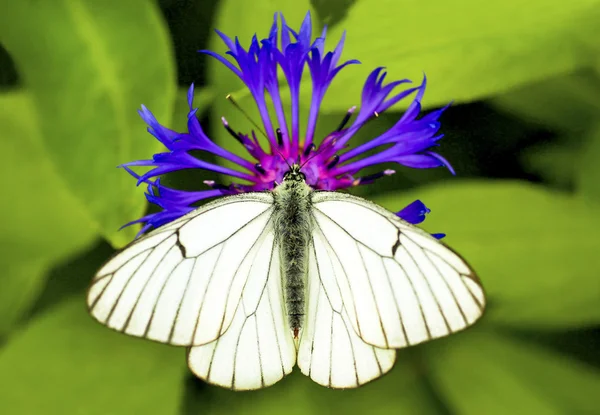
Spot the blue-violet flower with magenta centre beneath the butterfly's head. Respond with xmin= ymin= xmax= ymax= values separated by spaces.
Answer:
xmin=122 ymin=13 xmax=453 ymax=237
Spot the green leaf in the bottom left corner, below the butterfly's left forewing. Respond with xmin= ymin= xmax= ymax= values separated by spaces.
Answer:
xmin=0 ymin=297 xmax=185 ymax=415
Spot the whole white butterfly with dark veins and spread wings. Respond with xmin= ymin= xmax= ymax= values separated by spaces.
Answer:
xmin=87 ymin=165 xmax=485 ymax=390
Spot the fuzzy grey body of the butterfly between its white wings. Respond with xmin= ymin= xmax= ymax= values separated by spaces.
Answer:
xmin=273 ymin=169 xmax=312 ymax=344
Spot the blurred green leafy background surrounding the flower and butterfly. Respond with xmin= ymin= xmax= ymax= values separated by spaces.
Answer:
xmin=0 ymin=0 xmax=600 ymax=415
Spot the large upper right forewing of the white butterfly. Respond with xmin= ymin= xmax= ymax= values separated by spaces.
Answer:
xmin=309 ymin=192 xmax=485 ymax=349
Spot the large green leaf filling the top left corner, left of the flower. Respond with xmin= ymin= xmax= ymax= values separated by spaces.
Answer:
xmin=0 ymin=0 xmax=175 ymax=246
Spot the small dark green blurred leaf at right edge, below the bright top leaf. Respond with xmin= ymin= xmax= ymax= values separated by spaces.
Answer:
xmin=490 ymin=71 xmax=600 ymax=132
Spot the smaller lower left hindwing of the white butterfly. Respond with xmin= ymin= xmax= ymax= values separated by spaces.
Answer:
xmin=188 ymin=234 xmax=296 ymax=390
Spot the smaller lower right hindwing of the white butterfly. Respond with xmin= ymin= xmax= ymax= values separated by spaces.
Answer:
xmin=298 ymin=231 xmax=396 ymax=388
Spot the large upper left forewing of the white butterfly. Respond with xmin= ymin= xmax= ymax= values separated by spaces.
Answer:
xmin=87 ymin=193 xmax=274 ymax=346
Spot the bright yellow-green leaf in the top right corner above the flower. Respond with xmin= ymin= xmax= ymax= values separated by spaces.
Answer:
xmin=304 ymin=0 xmax=600 ymax=111
